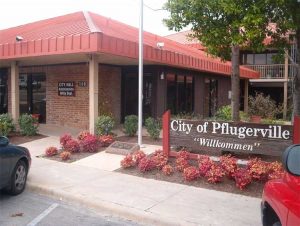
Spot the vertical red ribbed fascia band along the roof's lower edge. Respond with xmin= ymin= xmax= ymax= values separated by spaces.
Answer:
xmin=0 ymin=32 xmax=259 ymax=79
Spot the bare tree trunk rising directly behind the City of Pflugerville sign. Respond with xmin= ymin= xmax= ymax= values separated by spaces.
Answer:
xmin=231 ymin=45 xmax=240 ymax=122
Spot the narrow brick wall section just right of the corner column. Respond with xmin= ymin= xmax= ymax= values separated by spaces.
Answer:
xmin=99 ymin=65 xmax=121 ymax=123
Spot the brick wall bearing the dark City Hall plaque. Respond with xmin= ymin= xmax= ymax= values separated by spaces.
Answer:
xmin=20 ymin=63 xmax=89 ymax=129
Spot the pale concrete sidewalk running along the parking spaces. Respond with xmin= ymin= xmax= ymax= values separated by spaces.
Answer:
xmin=23 ymin=137 xmax=261 ymax=226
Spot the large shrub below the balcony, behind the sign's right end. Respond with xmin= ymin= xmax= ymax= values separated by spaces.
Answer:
xmin=249 ymin=93 xmax=279 ymax=119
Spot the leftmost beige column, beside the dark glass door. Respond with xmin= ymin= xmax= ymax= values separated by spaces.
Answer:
xmin=10 ymin=61 xmax=20 ymax=123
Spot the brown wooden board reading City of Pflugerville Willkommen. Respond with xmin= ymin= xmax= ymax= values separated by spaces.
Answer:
xmin=170 ymin=119 xmax=293 ymax=156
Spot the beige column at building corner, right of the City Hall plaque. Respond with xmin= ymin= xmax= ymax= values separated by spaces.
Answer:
xmin=89 ymin=55 xmax=99 ymax=134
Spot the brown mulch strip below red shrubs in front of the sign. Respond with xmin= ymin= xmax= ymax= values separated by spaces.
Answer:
xmin=116 ymin=158 xmax=264 ymax=198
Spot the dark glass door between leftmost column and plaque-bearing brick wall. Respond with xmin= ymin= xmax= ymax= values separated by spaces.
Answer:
xmin=19 ymin=74 xmax=46 ymax=123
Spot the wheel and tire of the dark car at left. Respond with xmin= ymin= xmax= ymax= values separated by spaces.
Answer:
xmin=8 ymin=160 xmax=28 ymax=195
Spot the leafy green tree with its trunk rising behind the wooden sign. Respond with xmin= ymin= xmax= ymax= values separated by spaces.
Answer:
xmin=164 ymin=0 xmax=292 ymax=121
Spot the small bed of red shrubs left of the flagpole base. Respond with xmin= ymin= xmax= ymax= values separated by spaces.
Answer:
xmin=44 ymin=131 xmax=114 ymax=162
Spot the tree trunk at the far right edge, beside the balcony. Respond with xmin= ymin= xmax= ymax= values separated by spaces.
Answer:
xmin=293 ymin=28 xmax=300 ymax=116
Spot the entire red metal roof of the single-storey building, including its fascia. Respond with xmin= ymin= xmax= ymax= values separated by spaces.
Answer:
xmin=0 ymin=12 xmax=259 ymax=78
